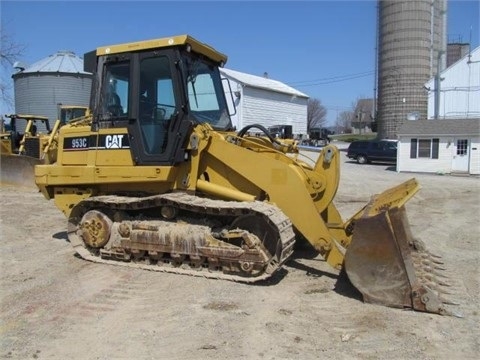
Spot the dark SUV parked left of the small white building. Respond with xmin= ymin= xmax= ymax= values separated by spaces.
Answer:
xmin=347 ymin=140 xmax=397 ymax=164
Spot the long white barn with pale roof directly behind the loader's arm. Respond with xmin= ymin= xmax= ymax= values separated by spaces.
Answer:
xmin=220 ymin=68 xmax=308 ymax=135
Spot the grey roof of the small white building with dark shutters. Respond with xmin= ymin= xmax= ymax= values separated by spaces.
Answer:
xmin=397 ymin=119 xmax=480 ymax=136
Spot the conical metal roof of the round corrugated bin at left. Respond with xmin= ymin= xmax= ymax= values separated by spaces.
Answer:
xmin=21 ymin=50 xmax=90 ymax=75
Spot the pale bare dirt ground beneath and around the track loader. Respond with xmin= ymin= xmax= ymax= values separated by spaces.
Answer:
xmin=0 ymin=144 xmax=480 ymax=360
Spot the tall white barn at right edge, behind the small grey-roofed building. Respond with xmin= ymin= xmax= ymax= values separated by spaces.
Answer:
xmin=425 ymin=47 xmax=480 ymax=119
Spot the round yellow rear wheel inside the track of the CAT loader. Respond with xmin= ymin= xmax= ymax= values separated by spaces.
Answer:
xmin=79 ymin=210 xmax=112 ymax=249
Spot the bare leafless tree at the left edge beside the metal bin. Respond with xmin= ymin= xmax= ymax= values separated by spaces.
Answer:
xmin=0 ymin=23 xmax=25 ymax=106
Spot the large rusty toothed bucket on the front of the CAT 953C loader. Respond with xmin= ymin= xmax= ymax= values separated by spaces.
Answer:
xmin=345 ymin=180 xmax=449 ymax=314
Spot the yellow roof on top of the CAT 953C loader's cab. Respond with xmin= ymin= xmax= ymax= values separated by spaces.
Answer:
xmin=97 ymin=35 xmax=227 ymax=64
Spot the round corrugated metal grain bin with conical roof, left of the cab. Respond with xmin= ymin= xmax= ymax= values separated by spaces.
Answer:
xmin=12 ymin=51 xmax=92 ymax=131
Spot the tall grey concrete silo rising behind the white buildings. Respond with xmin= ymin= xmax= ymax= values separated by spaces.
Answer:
xmin=377 ymin=0 xmax=447 ymax=139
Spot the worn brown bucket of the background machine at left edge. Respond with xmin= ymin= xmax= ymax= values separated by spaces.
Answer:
xmin=0 ymin=154 xmax=42 ymax=188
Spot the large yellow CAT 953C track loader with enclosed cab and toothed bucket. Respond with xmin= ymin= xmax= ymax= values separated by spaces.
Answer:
xmin=35 ymin=35 xmax=454 ymax=314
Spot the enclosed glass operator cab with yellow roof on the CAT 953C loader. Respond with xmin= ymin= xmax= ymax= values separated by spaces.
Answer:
xmin=85 ymin=36 xmax=233 ymax=165
